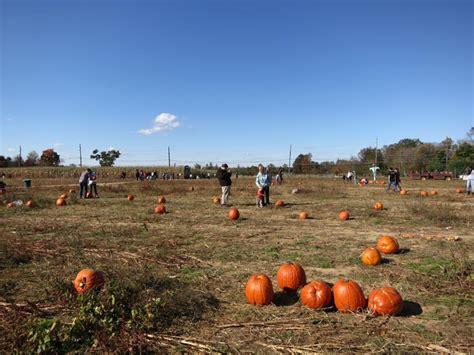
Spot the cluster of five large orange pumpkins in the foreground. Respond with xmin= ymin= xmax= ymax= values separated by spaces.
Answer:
xmin=245 ymin=263 xmax=403 ymax=316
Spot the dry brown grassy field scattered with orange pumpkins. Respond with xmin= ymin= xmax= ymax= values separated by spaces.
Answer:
xmin=0 ymin=172 xmax=474 ymax=353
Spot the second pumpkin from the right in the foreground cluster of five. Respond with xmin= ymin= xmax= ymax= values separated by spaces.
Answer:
xmin=332 ymin=279 xmax=367 ymax=312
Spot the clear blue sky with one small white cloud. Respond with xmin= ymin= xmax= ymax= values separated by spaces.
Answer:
xmin=0 ymin=0 xmax=474 ymax=165
